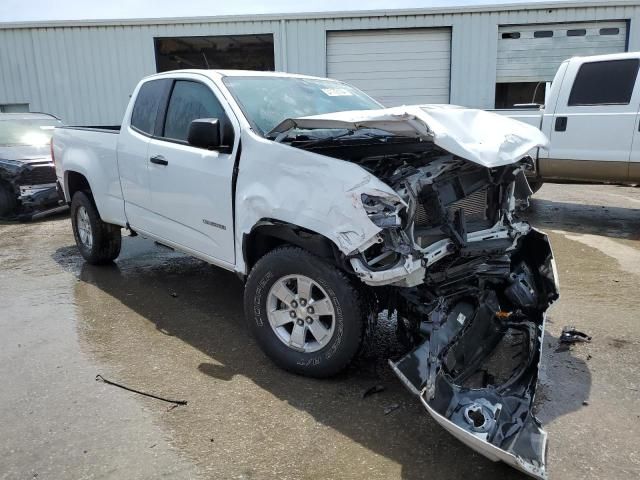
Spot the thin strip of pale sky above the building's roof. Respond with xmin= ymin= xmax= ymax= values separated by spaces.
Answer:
xmin=0 ymin=0 xmax=556 ymax=22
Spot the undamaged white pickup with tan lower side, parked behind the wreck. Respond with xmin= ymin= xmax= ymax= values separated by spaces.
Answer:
xmin=497 ymin=52 xmax=640 ymax=190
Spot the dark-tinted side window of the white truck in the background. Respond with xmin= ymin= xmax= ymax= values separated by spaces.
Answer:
xmin=568 ymin=58 xmax=640 ymax=107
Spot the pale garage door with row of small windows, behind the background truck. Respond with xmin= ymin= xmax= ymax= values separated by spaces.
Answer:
xmin=496 ymin=21 xmax=627 ymax=83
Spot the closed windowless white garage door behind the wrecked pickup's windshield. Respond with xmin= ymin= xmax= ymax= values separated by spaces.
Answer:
xmin=327 ymin=28 xmax=451 ymax=107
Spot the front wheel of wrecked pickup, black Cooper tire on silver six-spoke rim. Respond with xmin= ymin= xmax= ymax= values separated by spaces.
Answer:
xmin=244 ymin=247 xmax=365 ymax=378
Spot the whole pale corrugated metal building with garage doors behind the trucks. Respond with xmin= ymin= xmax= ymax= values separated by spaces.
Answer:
xmin=0 ymin=0 xmax=640 ymax=125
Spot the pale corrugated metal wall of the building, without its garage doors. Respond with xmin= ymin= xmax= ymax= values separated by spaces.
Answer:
xmin=0 ymin=1 xmax=640 ymax=125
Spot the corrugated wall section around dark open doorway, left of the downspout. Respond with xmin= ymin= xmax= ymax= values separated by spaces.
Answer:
xmin=0 ymin=21 xmax=282 ymax=125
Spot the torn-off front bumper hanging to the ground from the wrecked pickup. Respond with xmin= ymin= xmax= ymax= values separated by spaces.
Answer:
xmin=390 ymin=229 xmax=558 ymax=479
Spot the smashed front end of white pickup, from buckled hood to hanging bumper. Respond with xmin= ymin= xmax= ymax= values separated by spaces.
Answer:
xmin=275 ymin=107 xmax=558 ymax=478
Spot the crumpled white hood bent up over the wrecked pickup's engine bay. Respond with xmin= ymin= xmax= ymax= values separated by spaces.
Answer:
xmin=269 ymin=105 xmax=549 ymax=168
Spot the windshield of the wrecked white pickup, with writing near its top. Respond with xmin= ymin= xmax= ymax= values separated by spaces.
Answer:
xmin=223 ymin=76 xmax=383 ymax=135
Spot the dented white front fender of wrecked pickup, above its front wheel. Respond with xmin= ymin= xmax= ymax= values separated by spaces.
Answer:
xmin=236 ymin=129 xmax=404 ymax=272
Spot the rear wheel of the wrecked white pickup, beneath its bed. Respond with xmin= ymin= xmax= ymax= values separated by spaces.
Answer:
xmin=70 ymin=192 xmax=122 ymax=265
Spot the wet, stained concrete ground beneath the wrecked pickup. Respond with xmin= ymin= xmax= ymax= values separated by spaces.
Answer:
xmin=0 ymin=185 xmax=640 ymax=479
